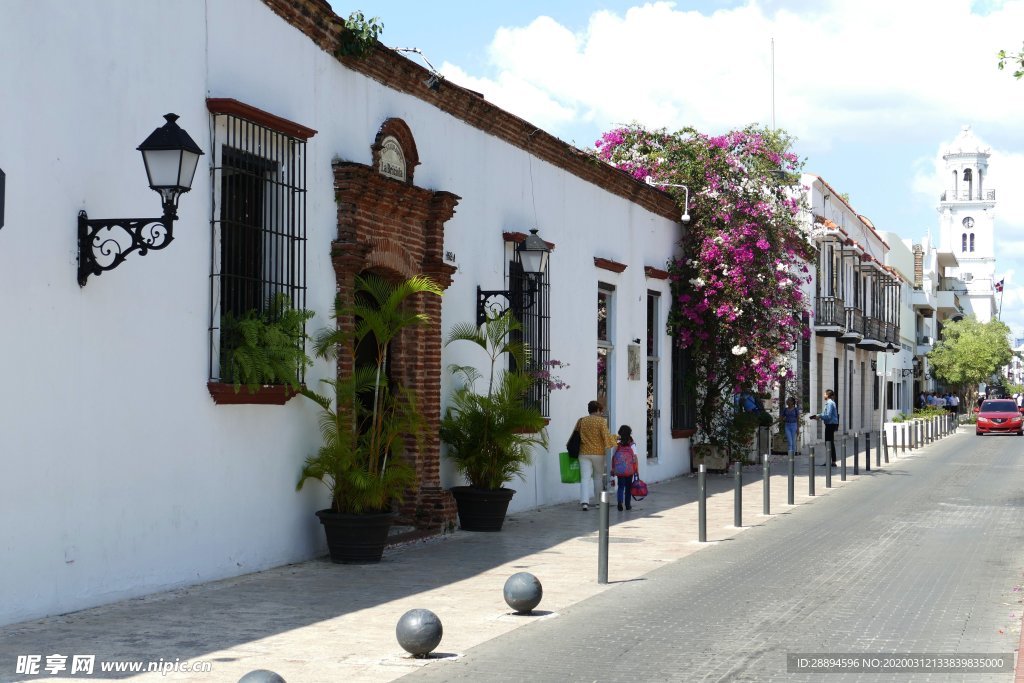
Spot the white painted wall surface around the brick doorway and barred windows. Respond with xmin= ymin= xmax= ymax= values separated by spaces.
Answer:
xmin=0 ymin=0 xmax=689 ymax=624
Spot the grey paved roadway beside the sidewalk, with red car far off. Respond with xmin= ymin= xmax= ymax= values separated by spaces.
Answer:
xmin=402 ymin=431 xmax=1024 ymax=683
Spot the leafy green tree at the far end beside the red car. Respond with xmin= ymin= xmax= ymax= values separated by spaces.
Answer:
xmin=928 ymin=315 xmax=1014 ymax=400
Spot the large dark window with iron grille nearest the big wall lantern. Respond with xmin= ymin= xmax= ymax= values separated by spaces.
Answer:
xmin=210 ymin=105 xmax=305 ymax=382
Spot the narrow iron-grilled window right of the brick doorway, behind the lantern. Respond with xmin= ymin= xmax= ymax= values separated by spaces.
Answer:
xmin=508 ymin=249 xmax=551 ymax=416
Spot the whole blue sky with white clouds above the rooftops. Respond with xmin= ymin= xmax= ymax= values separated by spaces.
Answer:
xmin=332 ymin=0 xmax=1024 ymax=336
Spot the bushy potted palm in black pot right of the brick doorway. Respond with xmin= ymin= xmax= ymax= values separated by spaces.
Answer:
xmin=440 ymin=311 xmax=548 ymax=531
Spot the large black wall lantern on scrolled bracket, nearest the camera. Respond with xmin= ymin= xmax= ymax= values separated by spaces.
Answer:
xmin=78 ymin=114 xmax=203 ymax=287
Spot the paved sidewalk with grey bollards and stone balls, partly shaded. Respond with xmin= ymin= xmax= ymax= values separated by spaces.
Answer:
xmin=0 ymin=430 xmax=942 ymax=683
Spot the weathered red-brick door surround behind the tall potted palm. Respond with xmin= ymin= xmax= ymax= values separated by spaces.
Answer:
xmin=331 ymin=157 xmax=459 ymax=530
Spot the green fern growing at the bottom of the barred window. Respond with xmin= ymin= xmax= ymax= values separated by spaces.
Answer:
xmin=220 ymin=293 xmax=313 ymax=393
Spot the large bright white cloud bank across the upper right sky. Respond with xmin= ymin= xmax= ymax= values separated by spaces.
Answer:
xmin=442 ymin=0 xmax=1024 ymax=148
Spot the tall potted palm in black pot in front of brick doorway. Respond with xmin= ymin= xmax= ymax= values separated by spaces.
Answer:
xmin=296 ymin=274 xmax=441 ymax=562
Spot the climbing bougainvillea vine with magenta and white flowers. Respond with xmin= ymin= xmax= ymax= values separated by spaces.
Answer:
xmin=596 ymin=125 xmax=812 ymax=444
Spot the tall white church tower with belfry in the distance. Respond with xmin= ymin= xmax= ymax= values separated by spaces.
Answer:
xmin=939 ymin=126 xmax=997 ymax=323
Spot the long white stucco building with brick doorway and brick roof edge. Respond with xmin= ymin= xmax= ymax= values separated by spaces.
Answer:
xmin=0 ymin=0 xmax=696 ymax=624
